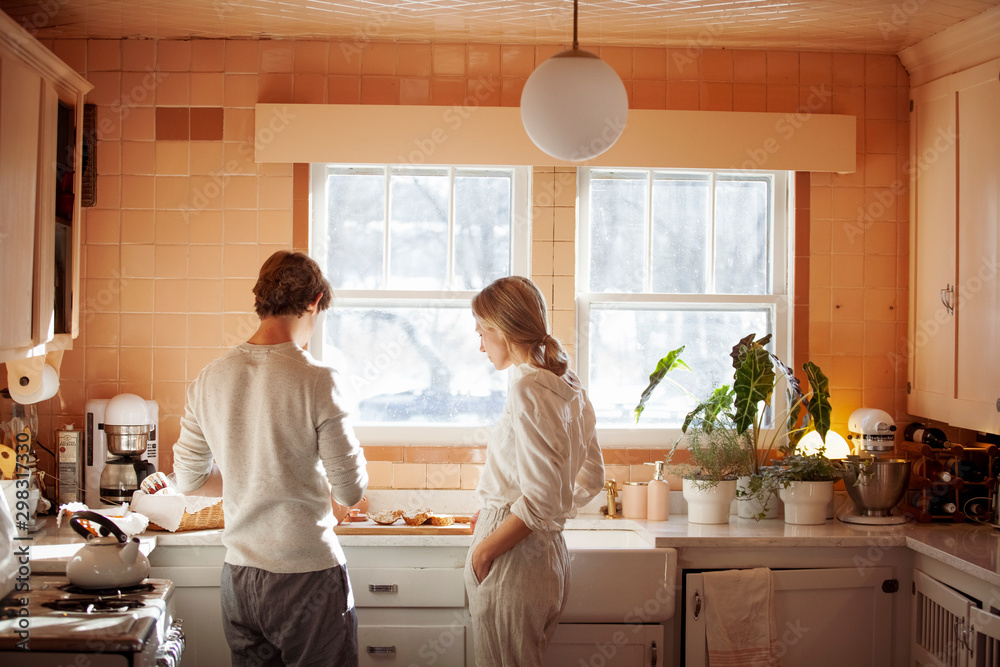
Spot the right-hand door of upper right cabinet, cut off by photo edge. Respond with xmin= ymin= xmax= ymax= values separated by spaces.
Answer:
xmin=951 ymin=60 xmax=1000 ymax=433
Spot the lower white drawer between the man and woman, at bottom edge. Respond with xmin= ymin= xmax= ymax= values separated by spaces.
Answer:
xmin=358 ymin=625 xmax=465 ymax=667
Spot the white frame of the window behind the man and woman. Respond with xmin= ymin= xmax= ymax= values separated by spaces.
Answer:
xmin=309 ymin=163 xmax=531 ymax=446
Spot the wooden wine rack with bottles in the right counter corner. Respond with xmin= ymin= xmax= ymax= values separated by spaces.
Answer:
xmin=900 ymin=440 xmax=998 ymax=523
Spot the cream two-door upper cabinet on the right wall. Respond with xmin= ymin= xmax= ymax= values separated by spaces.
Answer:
xmin=907 ymin=60 xmax=1000 ymax=433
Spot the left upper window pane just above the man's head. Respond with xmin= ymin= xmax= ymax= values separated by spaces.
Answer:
xmin=330 ymin=169 xmax=385 ymax=289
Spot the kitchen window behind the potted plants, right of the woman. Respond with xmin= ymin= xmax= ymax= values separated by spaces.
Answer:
xmin=577 ymin=169 xmax=791 ymax=444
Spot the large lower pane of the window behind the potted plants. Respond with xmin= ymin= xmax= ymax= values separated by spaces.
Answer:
xmin=588 ymin=304 xmax=773 ymax=428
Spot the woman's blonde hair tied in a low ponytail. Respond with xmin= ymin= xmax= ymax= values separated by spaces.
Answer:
xmin=472 ymin=276 xmax=577 ymax=384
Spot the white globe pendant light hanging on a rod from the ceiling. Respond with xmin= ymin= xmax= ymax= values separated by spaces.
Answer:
xmin=521 ymin=0 xmax=628 ymax=162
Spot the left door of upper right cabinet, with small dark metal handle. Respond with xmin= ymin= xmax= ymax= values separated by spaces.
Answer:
xmin=907 ymin=73 xmax=958 ymax=422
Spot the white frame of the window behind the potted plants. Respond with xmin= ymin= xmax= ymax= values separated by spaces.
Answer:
xmin=576 ymin=167 xmax=795 ymax=449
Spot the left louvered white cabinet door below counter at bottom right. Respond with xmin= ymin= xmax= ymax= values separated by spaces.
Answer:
xmin=910 ymin=570 xmax=973 ymax=667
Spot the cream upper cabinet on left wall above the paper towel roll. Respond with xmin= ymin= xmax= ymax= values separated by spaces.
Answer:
xmin=0 ymin=12 xmax=93 ymax=361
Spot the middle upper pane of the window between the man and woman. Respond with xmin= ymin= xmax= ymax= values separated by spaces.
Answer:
xmin=389 ymin=169 xmax=451 ymax=290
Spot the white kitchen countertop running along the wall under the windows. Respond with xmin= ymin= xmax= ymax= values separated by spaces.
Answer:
xmin=25 ymin=514 xmax=1000 ymax=586
